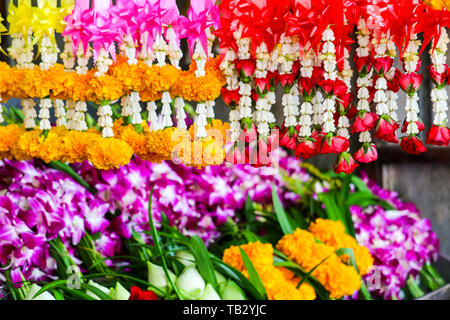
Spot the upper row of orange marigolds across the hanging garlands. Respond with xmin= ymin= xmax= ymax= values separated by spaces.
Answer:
xmin=0 ymin=56 xmax=225 ymax=102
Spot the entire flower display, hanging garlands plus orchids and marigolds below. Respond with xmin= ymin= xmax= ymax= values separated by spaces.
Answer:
xmin=0 ymin=0 xmax=450 ymax=300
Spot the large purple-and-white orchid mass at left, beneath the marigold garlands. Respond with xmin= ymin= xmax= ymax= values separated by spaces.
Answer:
xmin=0 ymin=151 xmax=308 ymax=283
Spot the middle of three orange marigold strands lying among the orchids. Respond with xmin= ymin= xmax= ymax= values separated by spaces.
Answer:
xmin=277 ymin=229 xmax=361 ymax=299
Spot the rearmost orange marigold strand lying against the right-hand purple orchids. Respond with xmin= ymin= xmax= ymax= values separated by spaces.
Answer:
xmin=308 ymin=219 xmax=373 ymax=275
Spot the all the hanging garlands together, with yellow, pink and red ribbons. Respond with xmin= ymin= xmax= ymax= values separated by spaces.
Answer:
xmin=0 ymin=0 xmax=450 ymax=173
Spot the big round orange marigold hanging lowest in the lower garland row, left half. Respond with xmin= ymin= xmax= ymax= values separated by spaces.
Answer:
xmin=86 ymin=137 xmax=133 ymax=170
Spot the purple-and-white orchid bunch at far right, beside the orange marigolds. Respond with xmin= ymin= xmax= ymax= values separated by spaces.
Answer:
xmin=350 ymin=175 xmax=439 ymax=299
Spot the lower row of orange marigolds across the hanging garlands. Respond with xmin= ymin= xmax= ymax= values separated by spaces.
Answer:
xmin=0 ymin=119 xmax=229 ymax=170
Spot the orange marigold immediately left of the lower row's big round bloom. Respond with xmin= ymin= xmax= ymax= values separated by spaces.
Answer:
xmin=63 ymin=130 xmax=101 ymax=163
